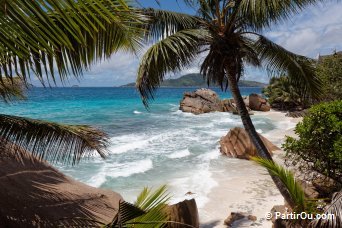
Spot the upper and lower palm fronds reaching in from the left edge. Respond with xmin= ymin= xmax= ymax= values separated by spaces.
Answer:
xmin=0 ymin=0 xmax=142 ymax=164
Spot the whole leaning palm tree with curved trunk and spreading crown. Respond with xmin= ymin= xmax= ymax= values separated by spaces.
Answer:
xmin=136 ymin=0 xmax=321 ymax=207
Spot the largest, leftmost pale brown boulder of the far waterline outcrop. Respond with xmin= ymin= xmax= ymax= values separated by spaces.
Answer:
xmin=179 ymin=89 xmax=223 ymax=114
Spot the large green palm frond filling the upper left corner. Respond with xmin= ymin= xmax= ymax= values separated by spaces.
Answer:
xmin=0 ymin=0 xmax=143 ymax=85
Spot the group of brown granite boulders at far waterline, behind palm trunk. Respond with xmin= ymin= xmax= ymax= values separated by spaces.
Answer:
xmin=179 ymin=89 xmax=270 ymax=115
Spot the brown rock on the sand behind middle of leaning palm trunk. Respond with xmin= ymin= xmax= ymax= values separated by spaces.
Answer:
xmin=220 ymin=127 xmax=279 ymax=159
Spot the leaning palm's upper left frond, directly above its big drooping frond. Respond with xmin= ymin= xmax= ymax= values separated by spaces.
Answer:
xmin=141 ymin=8 xmax=199 ymax=42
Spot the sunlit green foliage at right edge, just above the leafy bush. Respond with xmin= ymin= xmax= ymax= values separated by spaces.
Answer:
xmin=317 ymin=52 xmax=342 ymax=100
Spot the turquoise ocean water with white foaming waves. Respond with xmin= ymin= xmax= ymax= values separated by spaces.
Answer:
xmin=0 ymin=88 xmax=284 ymax=208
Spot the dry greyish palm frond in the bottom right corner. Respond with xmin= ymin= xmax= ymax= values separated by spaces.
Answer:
xmin=308 ymin=191 xmax=342 ymax=228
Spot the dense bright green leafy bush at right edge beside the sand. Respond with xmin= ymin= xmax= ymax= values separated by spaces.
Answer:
xmin=283 ymin=100 xmax=342 ymax=183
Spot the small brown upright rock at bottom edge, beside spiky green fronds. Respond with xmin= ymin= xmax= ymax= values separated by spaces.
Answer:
xmin=167 ymin=199 xmax=199 ymax=228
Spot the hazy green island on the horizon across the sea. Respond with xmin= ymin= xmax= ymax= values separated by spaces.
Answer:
xmin=120 ymin=74 xmax=267 ymax=87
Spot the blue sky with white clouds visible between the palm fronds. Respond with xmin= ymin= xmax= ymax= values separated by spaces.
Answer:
xmin=32 ymin=0 xmax=342 ymax=87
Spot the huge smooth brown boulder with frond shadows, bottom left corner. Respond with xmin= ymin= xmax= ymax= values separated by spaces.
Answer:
xmin=0 ymin=142 xmax=122 ymax=227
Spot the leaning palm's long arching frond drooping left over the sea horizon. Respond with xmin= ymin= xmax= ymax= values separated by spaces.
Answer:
xmin=136 ymin=29 xmax=209 ymax=107
